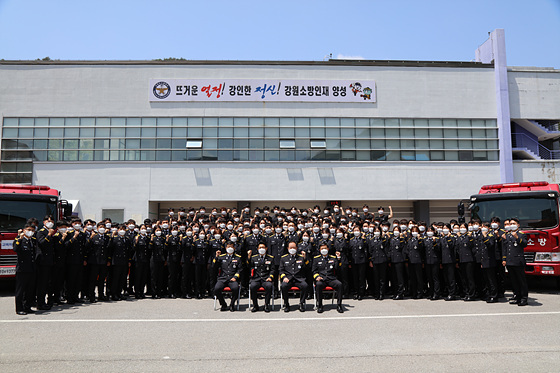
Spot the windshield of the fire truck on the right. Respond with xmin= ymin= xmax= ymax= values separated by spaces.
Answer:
xmin=471 ymin=198 xmax=558 ymax=229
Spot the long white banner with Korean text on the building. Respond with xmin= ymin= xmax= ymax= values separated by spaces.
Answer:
xmin=150 ymin=79 xmax=376 ymax=103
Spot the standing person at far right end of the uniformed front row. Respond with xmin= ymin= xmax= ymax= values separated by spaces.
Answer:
xmin=502 ymin=218 xmax=529 ymax=306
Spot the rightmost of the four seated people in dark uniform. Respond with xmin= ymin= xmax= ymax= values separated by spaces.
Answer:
xmin=312 ymin=243 xmax=344 ymax=313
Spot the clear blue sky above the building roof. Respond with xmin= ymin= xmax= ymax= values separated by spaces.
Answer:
xmin=0 ymin=0 xmax=560 ymax=69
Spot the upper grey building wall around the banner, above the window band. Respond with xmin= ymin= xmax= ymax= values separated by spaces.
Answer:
xmin=0 ymin=64 xmax=496 ymax=119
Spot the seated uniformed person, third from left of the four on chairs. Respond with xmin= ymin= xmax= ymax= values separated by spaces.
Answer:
xmin=279 ymin=242 xmax=309 ymax=312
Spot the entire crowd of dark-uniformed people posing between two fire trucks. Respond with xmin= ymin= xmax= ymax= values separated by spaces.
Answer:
xmin=14 ymin=205 xmax=528 ymax=315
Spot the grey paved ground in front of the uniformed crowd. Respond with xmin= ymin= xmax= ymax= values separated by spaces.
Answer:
xmin=0 ymin=282 xmax=560 ymax=373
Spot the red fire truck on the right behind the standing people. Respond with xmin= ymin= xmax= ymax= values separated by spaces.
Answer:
xmin=459 ymin=181 xmax=560 ymax=286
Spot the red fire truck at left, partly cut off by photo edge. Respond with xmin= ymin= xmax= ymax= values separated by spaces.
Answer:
xmin=0 ymin=184 xmax=72 ymax=278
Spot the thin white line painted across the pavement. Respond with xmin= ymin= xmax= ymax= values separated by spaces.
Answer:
xmin=0 ymin=311 xmax=560 ymax=324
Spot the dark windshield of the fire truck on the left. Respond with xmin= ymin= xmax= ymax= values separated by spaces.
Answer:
xmin=0 ymin=200 xmax=57 ymax=233
